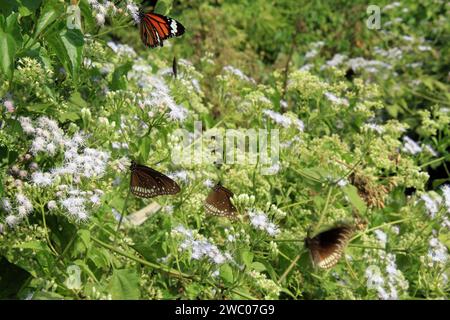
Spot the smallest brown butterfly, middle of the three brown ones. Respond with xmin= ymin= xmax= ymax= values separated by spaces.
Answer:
xmin=205 ymin=183 xmax=237 ymax=218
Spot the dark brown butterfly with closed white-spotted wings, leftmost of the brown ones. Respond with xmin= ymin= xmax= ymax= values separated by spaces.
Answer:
xmin=130 ymin=161 xmax=180 ymax=198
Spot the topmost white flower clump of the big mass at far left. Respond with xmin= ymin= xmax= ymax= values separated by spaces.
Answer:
xmin=19 ymin=117 xmax=65 ymax=156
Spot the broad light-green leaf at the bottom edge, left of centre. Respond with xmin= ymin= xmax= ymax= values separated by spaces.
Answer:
xmin=109 ymin=269 xmax=140 ymax=300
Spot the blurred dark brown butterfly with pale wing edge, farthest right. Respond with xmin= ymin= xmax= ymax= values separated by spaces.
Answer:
xmin=305 ymin=225 xmax=353 ymax=269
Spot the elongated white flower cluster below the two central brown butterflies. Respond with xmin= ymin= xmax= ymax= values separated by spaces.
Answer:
xmin=172 ymin=225 xmax=233 ymax=265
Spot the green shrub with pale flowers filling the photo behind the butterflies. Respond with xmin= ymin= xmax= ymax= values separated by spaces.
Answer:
xmin=0 ymin=0 xmax=450 ymax=299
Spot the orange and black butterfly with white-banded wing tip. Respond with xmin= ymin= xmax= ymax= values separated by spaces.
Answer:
xmin=139 ymin=1 xmax=185 ymax=48
